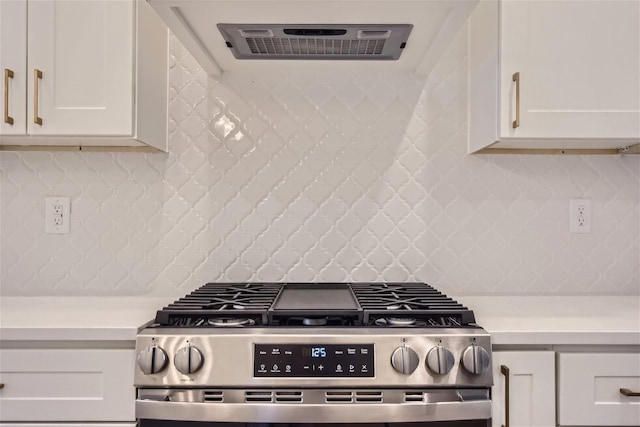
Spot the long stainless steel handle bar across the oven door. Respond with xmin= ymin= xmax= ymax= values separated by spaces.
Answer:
xmin=136 ymin=390 xmax=491 ymax=423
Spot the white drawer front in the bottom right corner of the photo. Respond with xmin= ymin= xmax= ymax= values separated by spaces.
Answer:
xmin=558 ymin=353 xmax=640 ymax=426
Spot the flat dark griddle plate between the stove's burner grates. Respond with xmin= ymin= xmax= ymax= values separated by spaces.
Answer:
xmin=270 ymin=283 xmax=362 ymax=318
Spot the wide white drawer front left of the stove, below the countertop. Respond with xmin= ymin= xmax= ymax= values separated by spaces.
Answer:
xmin=0 ymin=349 xmax=135 ymax=421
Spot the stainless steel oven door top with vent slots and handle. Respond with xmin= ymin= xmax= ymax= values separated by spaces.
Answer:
xmin=136 ymin=388 xmax=491 ymax=427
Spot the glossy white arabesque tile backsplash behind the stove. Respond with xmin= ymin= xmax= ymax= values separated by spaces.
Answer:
xmin=0 ymin=31 xmax=640 ymax=295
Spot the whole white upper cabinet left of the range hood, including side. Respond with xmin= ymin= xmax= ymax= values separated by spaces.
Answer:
xmin=0 ymin=0 xmax=168 ymax=150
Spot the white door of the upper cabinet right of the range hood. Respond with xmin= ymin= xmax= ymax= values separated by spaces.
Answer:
xmin=500 ymin=0 xmax=640 ymax=138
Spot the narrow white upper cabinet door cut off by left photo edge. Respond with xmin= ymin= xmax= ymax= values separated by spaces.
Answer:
xmin=0 ymin=0 xmax=27 ymax=135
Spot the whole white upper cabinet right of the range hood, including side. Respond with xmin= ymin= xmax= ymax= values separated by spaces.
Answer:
xmin=469 ymin=0 xmax=640 ymax=152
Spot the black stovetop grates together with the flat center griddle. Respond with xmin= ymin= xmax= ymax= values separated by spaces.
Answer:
xmin=155 ymin=282 xmax=477 ymax=328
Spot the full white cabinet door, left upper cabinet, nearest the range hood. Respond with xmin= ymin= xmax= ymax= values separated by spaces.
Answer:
xmin=26 ymin=0 xmax=135 ymax=136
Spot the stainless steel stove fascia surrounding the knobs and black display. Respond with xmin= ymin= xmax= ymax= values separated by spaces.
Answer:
xmin=135 ymin=327 xmax=493 ymax=387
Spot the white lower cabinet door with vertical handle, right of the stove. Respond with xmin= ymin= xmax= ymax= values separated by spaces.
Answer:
xmin=492 ymin=351 xmax=556 ymax=427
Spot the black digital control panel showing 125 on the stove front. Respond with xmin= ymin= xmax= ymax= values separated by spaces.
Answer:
xmin=253 ymin=344 xmax=375 ymax=378
